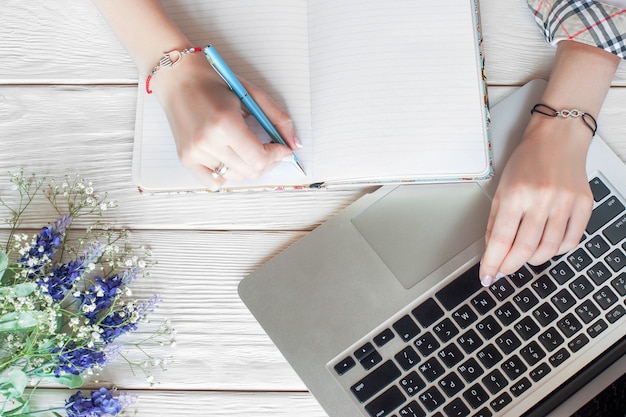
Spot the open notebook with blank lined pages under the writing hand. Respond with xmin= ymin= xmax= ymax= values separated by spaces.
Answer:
xmin=133 ymin=0 xmax=491 ymax=191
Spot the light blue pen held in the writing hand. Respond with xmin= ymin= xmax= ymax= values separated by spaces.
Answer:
xmin=204 ymin=45 xmax=306 ymax=175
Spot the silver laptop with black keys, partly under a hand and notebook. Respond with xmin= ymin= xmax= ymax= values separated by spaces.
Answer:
xmin=239 ymin=80 xmax=626 ymax=417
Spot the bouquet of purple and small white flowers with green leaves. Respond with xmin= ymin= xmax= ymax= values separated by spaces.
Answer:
xmin=0 ymin=172 xmax=174 ymax=417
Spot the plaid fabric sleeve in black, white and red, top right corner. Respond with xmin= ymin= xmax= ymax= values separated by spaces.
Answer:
xmin=527 ymin=0 xmax=626 ymax=58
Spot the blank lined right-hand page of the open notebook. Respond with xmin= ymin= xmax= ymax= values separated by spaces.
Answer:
xmin=309 ymin=0 xmax=488 ymax=180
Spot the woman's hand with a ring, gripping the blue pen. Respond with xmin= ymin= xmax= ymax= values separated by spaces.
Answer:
xmin=151 ymin=53 xmax=301 ymax=190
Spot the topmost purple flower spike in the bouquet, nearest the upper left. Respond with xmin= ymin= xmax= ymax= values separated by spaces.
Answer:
xmin=18 ymin=214 xmax=72 ymax=276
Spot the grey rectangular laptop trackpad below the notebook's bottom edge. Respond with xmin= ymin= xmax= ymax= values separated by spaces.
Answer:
xmin=352 ymin=183 xmax=491 ymax=289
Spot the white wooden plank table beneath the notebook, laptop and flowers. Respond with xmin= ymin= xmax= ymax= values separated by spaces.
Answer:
xmin=0 ymin=0 xmax=626 ymax=417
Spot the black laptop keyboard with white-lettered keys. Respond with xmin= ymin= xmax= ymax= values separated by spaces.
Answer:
xmin=331 ymin=177 xmax=626 ymax=417
